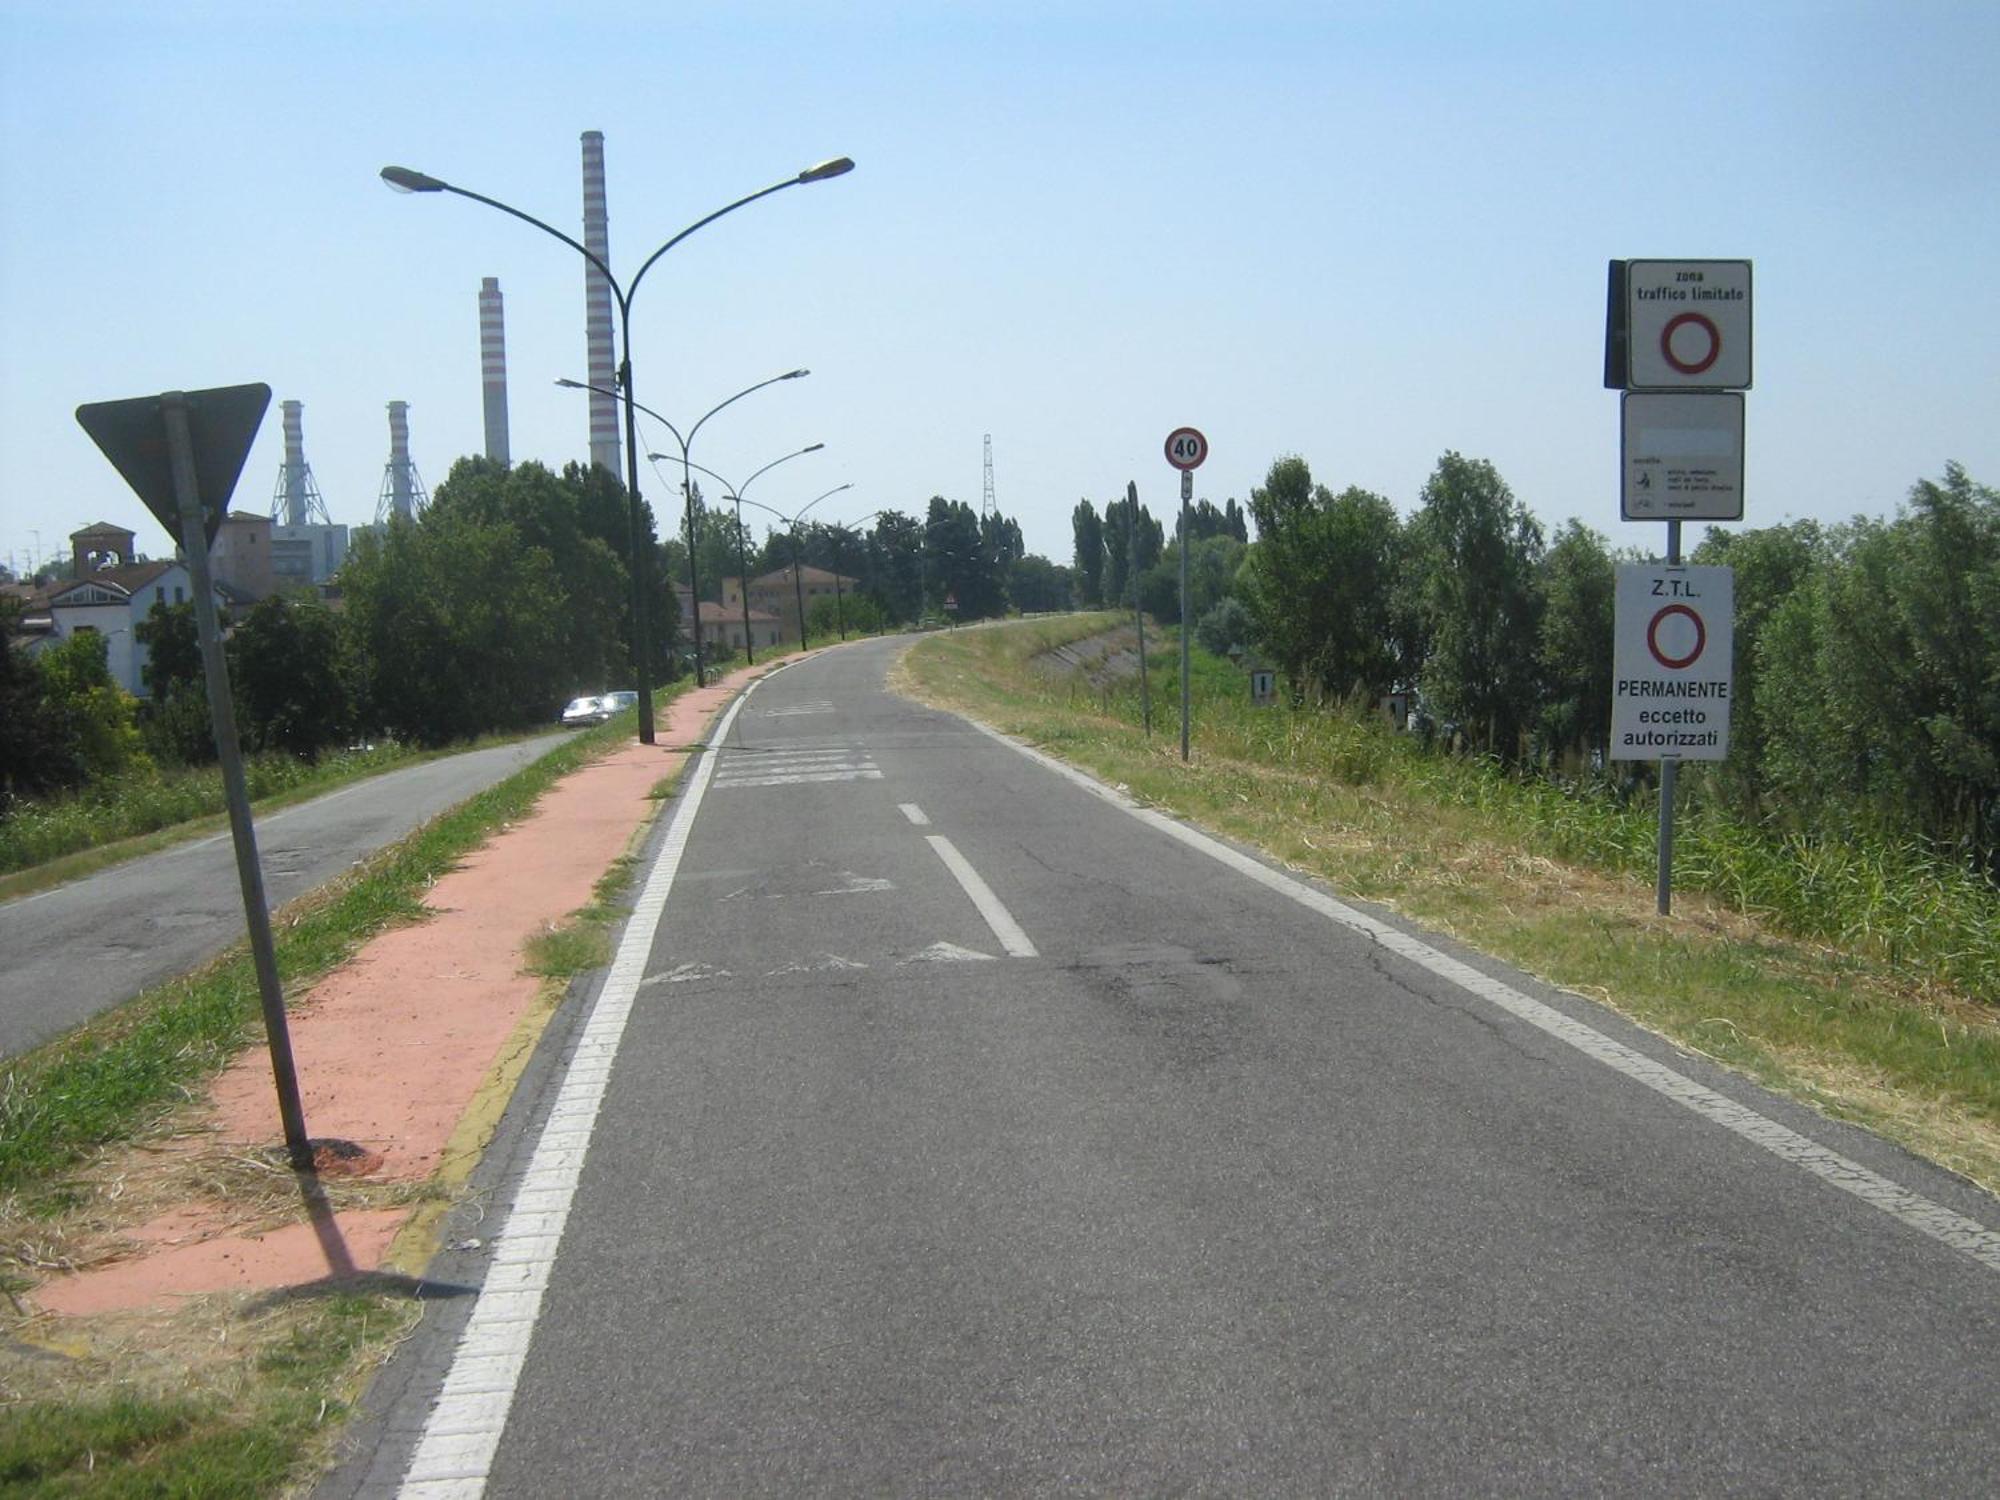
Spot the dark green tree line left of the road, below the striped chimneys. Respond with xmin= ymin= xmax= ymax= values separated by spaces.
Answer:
xmin=0 ymin=458 xmax=1068 ymax=816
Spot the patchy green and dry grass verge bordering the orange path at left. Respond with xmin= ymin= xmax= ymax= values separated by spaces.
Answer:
xmin=0 ymin=694 xmax=670 ymax=1496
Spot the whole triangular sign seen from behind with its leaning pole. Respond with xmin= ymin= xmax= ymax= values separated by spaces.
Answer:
xmin=76 ymin=386 xmax=314 ymax=1172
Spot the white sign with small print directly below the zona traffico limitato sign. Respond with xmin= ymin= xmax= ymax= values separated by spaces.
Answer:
xmin=1618 ymin=390 xmax=1744 ymax=520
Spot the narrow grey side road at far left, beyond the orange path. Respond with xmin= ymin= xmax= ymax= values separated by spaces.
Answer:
xmin=0 ymin=736 xmax=560 ymax=1056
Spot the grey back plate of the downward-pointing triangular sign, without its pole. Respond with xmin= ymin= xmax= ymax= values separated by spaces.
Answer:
xmin=76 ymin=384 xmax=270 ymax=544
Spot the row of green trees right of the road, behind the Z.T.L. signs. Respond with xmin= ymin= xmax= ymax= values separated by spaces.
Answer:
xmin=1074 ymin=452 xmax=2000 ymax=876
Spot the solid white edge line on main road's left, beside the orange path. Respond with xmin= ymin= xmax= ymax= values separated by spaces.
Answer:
xmin=400 ymin=682 xmax=756 ymax=1500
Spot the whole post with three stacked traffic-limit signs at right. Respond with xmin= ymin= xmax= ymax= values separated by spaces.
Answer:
xmin=1604 ymin=260 xmax=1750 ymax=916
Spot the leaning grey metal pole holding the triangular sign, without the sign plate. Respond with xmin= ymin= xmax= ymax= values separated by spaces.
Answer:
xmin=160 ymin=390 xmax=312 ymax=1172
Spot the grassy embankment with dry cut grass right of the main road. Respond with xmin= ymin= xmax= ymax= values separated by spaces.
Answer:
xmin=904 ymin=616 xmax=2000 ymax=1190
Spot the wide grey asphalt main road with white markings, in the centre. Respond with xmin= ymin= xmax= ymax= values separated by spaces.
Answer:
xmin=336 ymin=642 xmax=2000 ymax=1498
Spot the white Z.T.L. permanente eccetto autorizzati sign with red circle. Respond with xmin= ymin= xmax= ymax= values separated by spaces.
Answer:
xmin=1612 ymin=562 xmax=1736 ymax=760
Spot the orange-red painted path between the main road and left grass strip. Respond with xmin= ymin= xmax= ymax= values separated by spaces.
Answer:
xmin=28 ymin=658 xmax=790 ymax=1312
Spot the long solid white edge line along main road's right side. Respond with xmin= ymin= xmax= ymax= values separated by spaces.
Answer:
xmin=964 ymin=720 xmax=2000 ymax=1272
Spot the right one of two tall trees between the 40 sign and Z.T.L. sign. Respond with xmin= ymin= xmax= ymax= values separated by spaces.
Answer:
xmin=1408 ymin=452 xmax=1542 ymax=760
